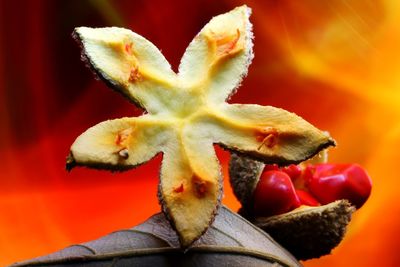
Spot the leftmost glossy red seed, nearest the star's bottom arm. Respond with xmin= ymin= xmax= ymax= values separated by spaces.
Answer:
xmin=253 ymin=170 xmax=300 ymax=217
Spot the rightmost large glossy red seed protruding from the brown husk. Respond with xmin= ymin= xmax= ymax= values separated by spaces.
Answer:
xmin=305 ymin=164 xmax=372 ymax=209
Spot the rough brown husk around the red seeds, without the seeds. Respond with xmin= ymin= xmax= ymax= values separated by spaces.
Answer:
xmin=229 ymin=153 xmax=355 ymax=260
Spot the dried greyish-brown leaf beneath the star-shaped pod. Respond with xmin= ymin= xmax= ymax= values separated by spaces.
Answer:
xmin=12 ymin=207 xmax=301 ymax=267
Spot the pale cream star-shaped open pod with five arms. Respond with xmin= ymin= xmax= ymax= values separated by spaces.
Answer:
xmin=67 ymin=6 xmax=334 ymax=247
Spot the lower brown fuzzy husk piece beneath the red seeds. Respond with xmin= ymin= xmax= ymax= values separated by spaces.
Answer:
xmin=254 ymin=200 xmax=355 ymax=260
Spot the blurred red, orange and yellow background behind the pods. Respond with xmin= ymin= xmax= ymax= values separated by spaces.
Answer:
xmin=0 ymin=0 xmax=400 ymax=266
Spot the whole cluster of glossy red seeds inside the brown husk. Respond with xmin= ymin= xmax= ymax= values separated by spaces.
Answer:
xmin=253 ymin=163 xmax=372 ymax=217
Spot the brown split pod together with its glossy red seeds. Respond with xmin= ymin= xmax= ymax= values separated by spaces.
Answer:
xmin=229 ymin=153 xmax=371 ymax=260
